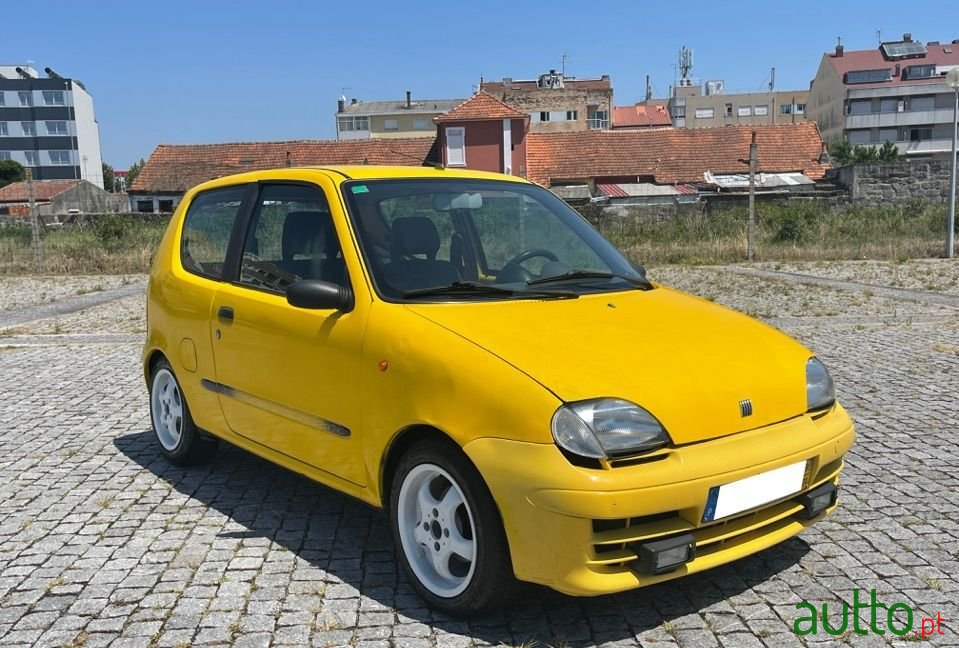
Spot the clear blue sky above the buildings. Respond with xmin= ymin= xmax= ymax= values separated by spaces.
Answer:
xmin=0 ymin=0 xmax=959 ymax=169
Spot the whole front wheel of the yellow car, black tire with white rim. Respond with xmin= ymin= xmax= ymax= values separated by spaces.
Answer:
xmin=390 ymin=441 xmax=515 ymax=616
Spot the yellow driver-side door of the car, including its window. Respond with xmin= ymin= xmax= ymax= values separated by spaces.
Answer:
xmin=210 ymin=183 xmax=369 ymax=486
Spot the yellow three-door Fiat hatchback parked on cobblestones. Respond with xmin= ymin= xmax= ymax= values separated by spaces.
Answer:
xmin=143 ymin=166 xmax=854 ymax=614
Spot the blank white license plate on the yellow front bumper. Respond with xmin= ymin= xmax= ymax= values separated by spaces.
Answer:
xmin=703 ymin=461 xmax=806 ymax=522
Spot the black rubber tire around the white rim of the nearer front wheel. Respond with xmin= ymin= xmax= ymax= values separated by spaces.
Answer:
xmin=389 ymin=440 xmax=516 ymax=617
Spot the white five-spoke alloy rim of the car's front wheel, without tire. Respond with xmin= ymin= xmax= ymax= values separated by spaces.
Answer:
xmin=397 ymin=463 xmax=477 ymax=598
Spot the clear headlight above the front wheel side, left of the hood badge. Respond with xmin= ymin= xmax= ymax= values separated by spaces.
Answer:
xmin=551 ymin=398 xmax=669 ymax=459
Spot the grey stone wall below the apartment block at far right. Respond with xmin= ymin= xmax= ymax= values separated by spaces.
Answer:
xmin=831 ymin=160 xmax=950 ymax=204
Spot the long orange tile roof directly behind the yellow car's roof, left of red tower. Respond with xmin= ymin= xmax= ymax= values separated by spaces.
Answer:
xmin=130 ymin=137 xmax=438 ymax=193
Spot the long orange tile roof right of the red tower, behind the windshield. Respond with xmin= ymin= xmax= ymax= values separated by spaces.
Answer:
xmin=526 ymin=122 xmax=828 ymax=185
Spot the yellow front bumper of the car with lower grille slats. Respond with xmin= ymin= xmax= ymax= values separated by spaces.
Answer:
xmin=464 ymin=404 xmax=855 ymax=596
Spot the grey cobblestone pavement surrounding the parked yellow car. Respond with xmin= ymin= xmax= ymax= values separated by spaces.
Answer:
xmin=0 ymin=262 xmax=959 ymax=648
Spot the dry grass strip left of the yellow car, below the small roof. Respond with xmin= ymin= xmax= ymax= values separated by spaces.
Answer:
xmin=0 ymin=214 xmax=166 ymax=274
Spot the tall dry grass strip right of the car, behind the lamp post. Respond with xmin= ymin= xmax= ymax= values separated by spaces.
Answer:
xmin=595 ymin=200 xmax=946 ymax=264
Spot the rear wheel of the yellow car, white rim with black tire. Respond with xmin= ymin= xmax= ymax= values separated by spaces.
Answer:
xmin=150 ymin=358 xmax=219 ymax=466
